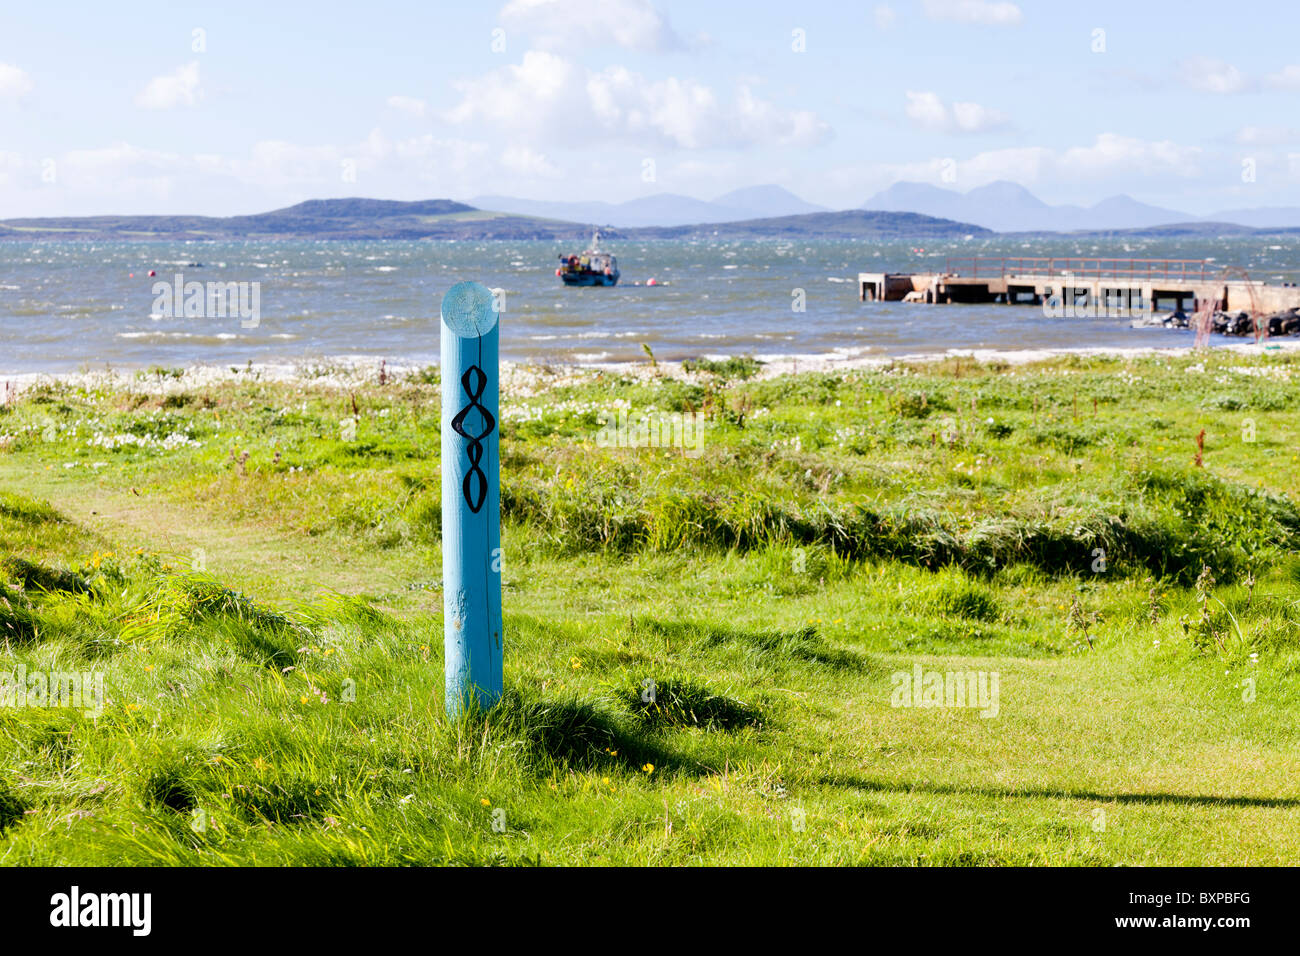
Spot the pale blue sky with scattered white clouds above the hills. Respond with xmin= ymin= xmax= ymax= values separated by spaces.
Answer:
xmin=0 ymin=0 xmax=1300 ymax=219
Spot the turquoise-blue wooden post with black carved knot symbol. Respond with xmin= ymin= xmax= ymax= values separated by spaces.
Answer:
xmin=442 ymin=282 xmax=502 ymax=717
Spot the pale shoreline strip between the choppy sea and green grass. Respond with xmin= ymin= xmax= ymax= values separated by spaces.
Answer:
xmin=0 ymin=338 xmax=1300 ymax=402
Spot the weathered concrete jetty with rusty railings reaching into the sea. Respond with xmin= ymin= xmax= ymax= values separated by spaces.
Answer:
xmin=858 ymin=256 xmax=1300 ymax=313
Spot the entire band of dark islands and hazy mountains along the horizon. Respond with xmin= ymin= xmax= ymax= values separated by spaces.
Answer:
xmin=0 ymin=182 xmax=1300 ymax=243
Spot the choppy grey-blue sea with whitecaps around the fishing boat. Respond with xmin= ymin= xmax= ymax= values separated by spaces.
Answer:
xmin=0 ymin=235 xmax=1300 ymax=375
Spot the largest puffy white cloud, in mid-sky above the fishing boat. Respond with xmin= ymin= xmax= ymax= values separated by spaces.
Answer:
xmin=445 ymin=49 xmax=829 ymax=150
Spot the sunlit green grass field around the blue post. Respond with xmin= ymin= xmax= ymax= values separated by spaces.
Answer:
xmin=0 ymin=352 xmax=1300 ymax=865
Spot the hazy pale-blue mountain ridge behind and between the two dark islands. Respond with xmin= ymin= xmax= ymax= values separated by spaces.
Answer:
xmin=469 ymin=186 xmax=826 ymax=228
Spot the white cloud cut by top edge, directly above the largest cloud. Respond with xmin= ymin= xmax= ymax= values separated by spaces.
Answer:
xmin=501 ymin=0 xmax=685 ymax=52
